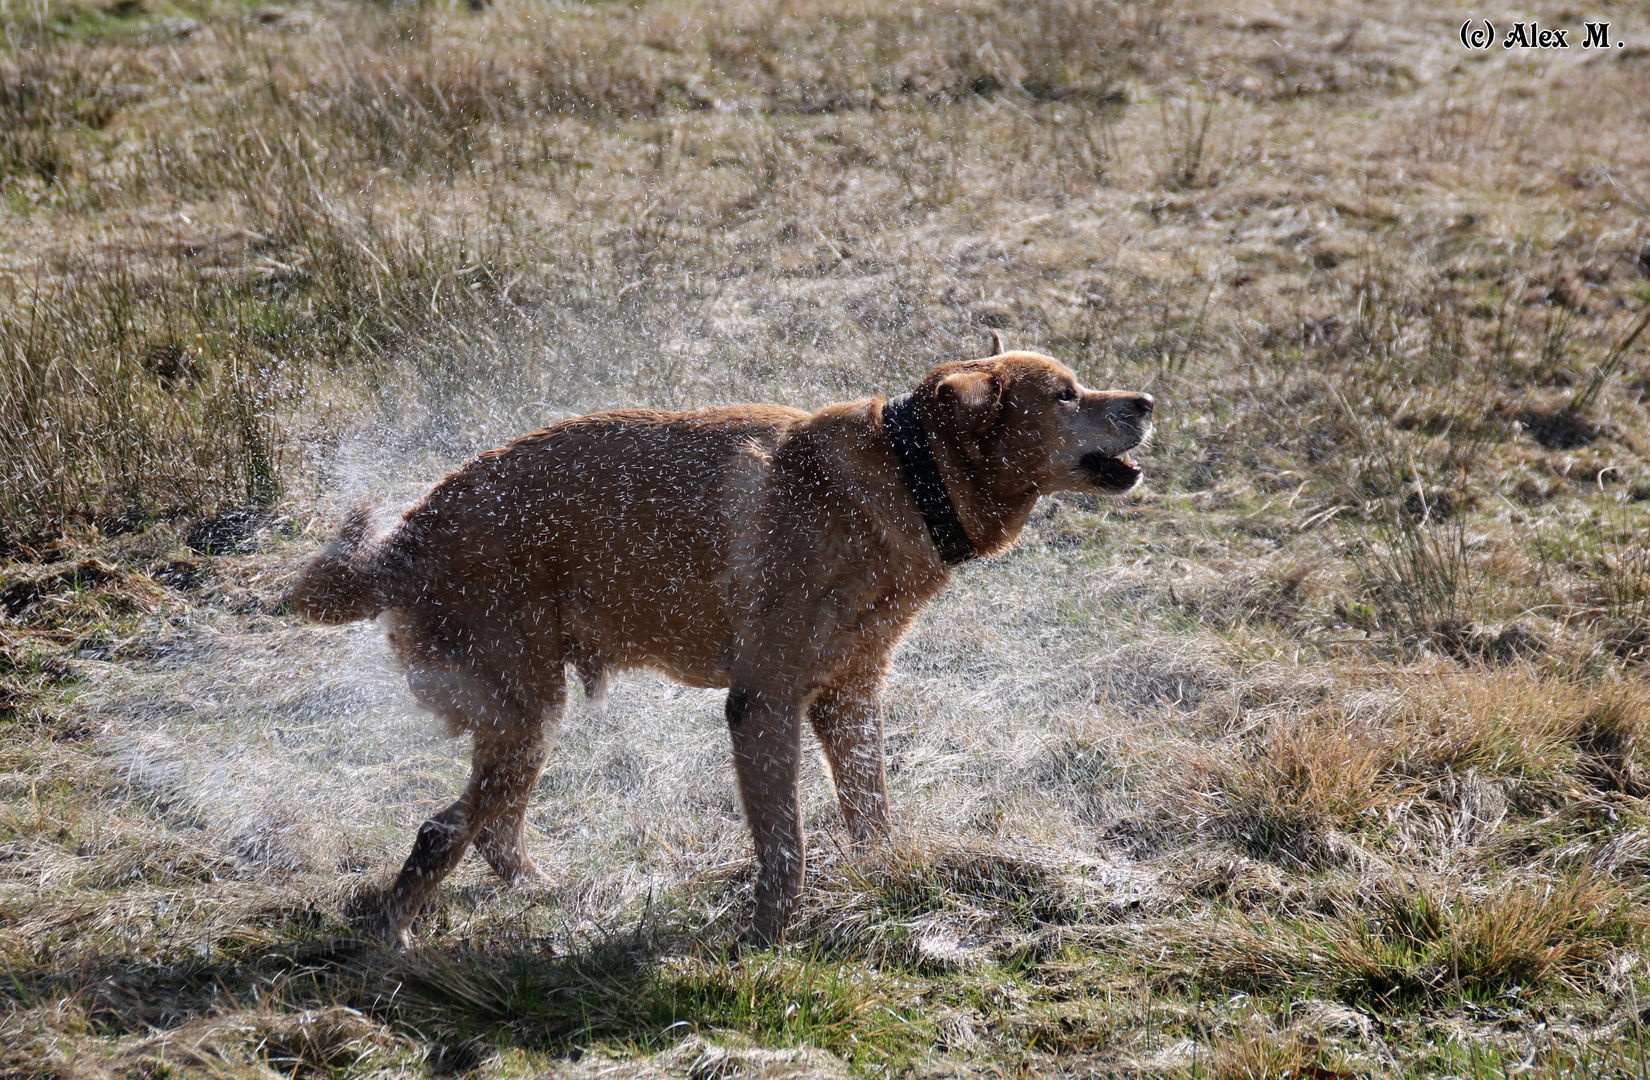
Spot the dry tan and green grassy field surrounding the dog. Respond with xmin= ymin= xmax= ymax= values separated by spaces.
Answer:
xmin=0 ymin=0 xmax=1650 ymax=1080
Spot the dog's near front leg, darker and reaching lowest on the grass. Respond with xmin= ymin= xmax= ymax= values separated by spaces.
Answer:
xmin=728 ymin=681 xmax=804 ymax=945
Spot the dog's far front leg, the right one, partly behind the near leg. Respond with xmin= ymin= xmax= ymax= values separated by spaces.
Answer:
xmin=809 ymin=671 xmax=889 ymax=844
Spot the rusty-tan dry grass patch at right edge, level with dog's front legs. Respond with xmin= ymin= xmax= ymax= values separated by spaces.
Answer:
xmin=1162 ymin=668 xmax=1643 ymax=869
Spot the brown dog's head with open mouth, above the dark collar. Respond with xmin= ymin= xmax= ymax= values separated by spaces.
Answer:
xmin=921 ymin=353 xmax=1153 ymax=495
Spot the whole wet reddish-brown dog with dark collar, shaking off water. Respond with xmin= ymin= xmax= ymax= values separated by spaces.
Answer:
xmin=292 ymin=353 xmax=1152 ymax=941
